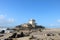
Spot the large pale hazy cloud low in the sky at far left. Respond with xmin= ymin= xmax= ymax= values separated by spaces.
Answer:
xmin=0 ymin=15 xmax=15 ymax=26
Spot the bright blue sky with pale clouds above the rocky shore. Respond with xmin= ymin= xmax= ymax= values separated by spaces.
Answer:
xmin=0 ymin=0 xmax=60 ymax=28
